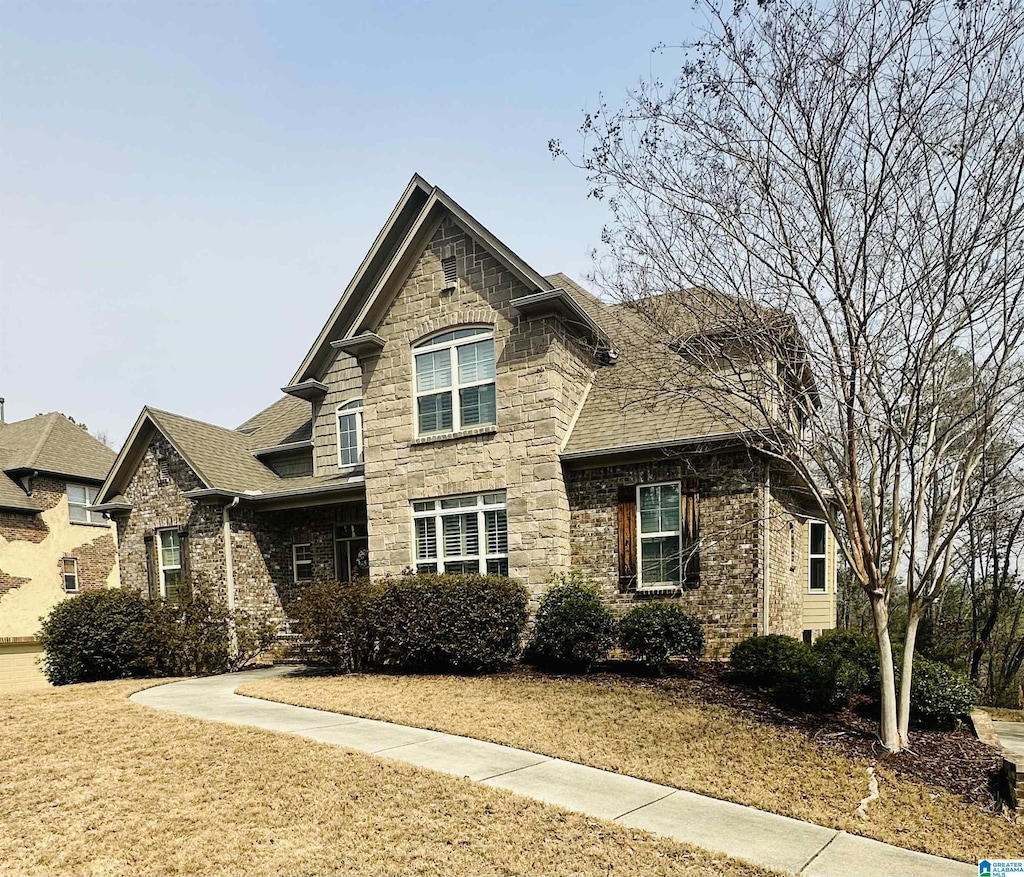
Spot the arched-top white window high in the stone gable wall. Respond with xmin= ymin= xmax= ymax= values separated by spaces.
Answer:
xmin=413 ymin=327 xmax=498 ymax=435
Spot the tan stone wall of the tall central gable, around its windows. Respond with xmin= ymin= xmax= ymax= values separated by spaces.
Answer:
xmin=362 ymin=219 xmax=592 ymax=590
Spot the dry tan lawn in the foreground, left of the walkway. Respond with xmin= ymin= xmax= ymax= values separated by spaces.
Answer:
xmin=0 ymin=681 xmax=770 ymax=877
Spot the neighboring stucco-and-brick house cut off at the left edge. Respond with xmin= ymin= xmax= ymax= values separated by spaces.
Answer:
xmin=0 ymin=412 xmax=120 ymax=692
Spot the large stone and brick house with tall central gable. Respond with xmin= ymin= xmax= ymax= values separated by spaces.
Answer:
xmin=95 ymin=176 xmax=836 ymax=655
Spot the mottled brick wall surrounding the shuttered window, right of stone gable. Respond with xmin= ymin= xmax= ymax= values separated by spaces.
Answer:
xmin=566 ymin=454 xmax=763 ymax=658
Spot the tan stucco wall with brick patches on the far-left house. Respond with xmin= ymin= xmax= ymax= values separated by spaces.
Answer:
xmin=0 ymin=478 xmax=120 ymax=637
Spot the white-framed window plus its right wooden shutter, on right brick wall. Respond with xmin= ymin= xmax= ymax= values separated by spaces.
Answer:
xmin=637 ymin=482 xmax=700 ymax=590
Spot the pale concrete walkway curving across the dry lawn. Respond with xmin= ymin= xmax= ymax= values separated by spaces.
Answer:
xmin=132 ymin=667 xmax=970 ymax=877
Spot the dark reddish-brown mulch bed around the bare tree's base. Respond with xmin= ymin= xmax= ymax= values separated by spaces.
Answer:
xmin=507 ymin=662 xmax=1002 ymax=811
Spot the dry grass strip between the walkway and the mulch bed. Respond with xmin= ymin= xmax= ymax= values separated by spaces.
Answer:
xmin=240 ymin=674 xmax=1024 ymax=862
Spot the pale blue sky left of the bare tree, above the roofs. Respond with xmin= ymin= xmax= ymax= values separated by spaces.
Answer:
xmin=0 ymin=0 xmax=694 ymax=445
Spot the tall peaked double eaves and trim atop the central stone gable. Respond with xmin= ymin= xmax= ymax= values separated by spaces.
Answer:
xmin=285 ymin=174 xmax=553 ymax=392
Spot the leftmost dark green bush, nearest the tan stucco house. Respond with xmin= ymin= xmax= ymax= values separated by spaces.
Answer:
xmin=39 ymin=590 xmax=159 ymax=685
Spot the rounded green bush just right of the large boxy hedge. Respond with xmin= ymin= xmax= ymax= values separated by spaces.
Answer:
xmin=528 ymin=576 xmax=615 ymax=672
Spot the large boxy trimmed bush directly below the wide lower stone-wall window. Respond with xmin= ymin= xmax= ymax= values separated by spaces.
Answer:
xmin=371 ymin=573 xmax=527 ymax=673
